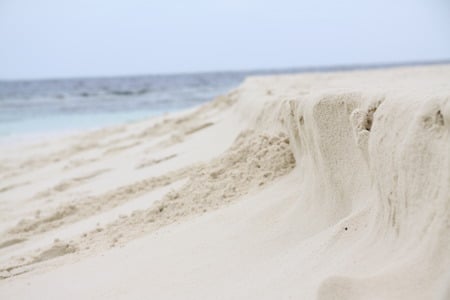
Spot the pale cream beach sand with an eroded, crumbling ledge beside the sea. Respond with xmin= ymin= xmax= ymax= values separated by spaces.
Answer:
xmin=0 ymin=65 xmax=450 ymax=300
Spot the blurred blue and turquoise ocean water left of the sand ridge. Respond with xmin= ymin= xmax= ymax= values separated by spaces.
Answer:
xmin=0 ymin=72 xmax=249 ymax=139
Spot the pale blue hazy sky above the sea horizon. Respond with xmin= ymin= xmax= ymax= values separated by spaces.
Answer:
xmin=0 ymin=0 xmax=450 ymax=80
